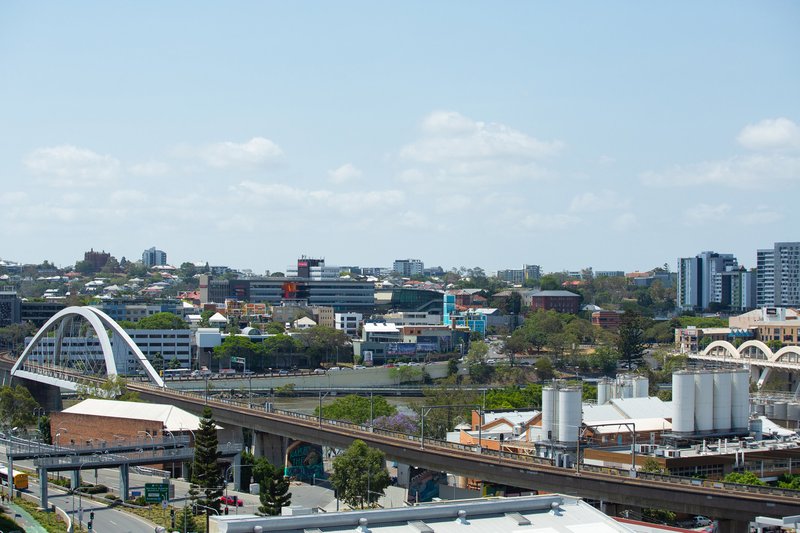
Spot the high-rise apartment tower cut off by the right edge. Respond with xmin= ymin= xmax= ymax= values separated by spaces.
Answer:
xmin=756 ymin=242 xmax=800 ymax=307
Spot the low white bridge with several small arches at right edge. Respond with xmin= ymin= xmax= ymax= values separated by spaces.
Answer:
xmin=689 ymin=340 xmax=800 ymax=388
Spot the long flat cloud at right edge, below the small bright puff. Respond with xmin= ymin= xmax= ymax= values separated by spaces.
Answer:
xmin=642 ymin=154 xmax=800 ymax=189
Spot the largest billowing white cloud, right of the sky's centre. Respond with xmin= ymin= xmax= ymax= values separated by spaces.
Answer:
xmin=399 ymin=111 xmax=563 ymax=187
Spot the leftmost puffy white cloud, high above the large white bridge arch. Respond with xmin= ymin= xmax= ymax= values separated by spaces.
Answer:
xmin=23 ymin=144 xmax=120 ymax=187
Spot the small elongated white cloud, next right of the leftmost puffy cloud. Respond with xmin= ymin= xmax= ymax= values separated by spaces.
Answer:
xmin=174 ymin=137 xmax=283 ymax=169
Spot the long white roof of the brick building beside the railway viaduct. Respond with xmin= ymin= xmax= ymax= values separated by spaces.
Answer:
xmin=62 ymin=398 xmax=209 ymax=431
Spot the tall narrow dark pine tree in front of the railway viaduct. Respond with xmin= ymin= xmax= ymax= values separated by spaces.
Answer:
xmin=192 ymin=406 xmax=222 ymax=511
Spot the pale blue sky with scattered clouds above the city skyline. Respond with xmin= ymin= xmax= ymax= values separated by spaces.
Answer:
xmin=0 ymin=0 xmax=800 ymax=272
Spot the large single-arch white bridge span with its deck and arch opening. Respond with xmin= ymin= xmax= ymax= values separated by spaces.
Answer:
xmin=11 ymin=306 xmax=164 ymax=390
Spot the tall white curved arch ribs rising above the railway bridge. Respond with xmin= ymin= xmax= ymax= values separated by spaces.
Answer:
xmin=11 ymin=306 xmax=164 ymax=387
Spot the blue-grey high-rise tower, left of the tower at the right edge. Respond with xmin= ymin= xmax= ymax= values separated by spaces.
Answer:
xmin=677 ymin=252 xmax=739 ymax=309
